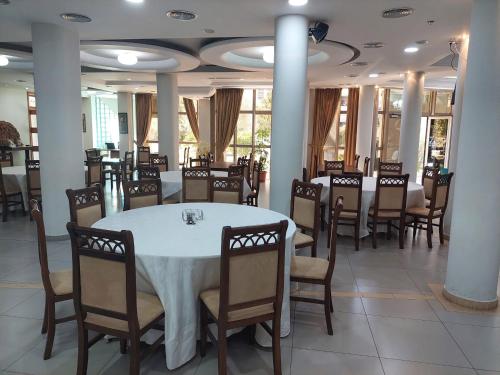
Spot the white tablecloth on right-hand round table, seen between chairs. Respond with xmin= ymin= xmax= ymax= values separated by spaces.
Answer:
xmin=311 ymin=176 xmax=425 ymax=237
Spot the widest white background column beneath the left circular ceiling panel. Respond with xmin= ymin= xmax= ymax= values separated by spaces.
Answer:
xmin=156 ymin=73 xmax=179 ymax=170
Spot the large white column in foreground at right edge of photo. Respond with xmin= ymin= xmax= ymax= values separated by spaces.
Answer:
xmin=445 ymin=0 xmax=500 ymax=307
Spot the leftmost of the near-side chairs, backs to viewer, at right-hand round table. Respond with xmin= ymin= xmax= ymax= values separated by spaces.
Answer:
xmin=327 ymin=174 xmax=363 ymax=250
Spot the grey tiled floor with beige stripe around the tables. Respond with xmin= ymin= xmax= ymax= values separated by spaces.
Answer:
xmin=0 ymin=186 xmax=500 ymax=375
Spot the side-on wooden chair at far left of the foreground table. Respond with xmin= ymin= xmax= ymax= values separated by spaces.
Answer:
xmin=30 ymin=199 xmax=75 ymax=360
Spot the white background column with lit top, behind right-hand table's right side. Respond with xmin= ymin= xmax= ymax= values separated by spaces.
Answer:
xmin=399 ymin=72 xmax=424 ymax=181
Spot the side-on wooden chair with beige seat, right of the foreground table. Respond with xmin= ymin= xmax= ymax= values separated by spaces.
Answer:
xmin=290 ymin=196 xmax=343 ymax=336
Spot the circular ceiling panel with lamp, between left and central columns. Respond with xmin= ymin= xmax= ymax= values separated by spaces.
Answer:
xmin=80 ymin=41 xmax=200 ymax=72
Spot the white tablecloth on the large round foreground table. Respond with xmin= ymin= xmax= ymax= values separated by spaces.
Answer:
xmin=94 ymin=203 xmax=296 ymax=369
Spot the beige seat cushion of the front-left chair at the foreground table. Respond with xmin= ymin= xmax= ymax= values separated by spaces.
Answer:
xmin=85 ymin=292 xmax=165 ymax=332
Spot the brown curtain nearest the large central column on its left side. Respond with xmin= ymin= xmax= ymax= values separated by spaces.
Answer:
xmin=215 ymin=89 xmax=243 ymax=161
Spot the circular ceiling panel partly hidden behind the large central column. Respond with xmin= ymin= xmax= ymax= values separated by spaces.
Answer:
xmin=200 ymin=37 xmax=359 ymax=71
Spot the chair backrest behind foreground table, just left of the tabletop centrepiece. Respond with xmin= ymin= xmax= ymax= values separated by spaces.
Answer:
xmin=123 ymin=178 xmax=162 ymax=211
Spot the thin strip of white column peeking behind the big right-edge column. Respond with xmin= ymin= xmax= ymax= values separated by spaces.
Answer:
xmin=444 ymin=36 xmax=469 ymax=236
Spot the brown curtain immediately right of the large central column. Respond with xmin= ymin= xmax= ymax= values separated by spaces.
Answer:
xmin=309 ymin=89 xmax=341 ymax=178
